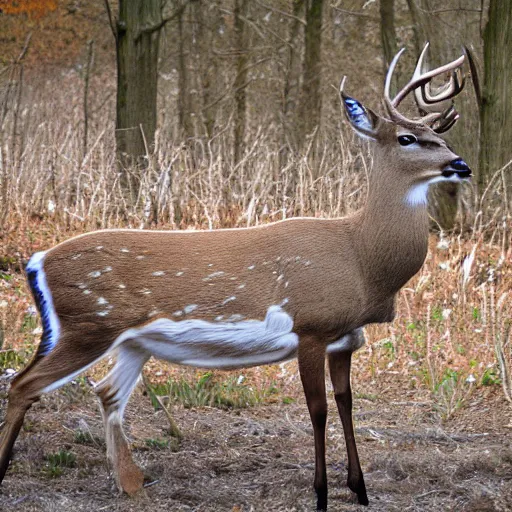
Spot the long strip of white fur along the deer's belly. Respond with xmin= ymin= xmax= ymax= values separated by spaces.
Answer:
xmin=114 ymin=306 xmax=299 ymax=369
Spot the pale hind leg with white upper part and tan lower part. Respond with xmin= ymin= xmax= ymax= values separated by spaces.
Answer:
xmin=96 ymin=344 xmax=150 ymax=496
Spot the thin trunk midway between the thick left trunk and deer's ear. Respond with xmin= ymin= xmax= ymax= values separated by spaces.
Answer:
xmin=233 ymin=0 xmax=249 ymax=165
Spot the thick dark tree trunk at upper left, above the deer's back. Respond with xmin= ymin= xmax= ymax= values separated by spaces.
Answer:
xmin=116 ymin=0 xmax=162 ymax=190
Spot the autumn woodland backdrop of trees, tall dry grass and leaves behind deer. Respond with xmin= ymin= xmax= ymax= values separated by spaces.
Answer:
xmin=0 ymin=0 xmax=512 ymax=510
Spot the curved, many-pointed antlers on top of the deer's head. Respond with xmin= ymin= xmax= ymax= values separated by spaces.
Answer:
xmin=384 ymin=43 xmax=464 ymax=133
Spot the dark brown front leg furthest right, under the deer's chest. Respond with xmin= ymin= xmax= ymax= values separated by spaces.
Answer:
xmin=329 ymin=332 xmax=368 ymax=505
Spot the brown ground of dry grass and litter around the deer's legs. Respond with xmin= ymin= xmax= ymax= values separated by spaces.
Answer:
xmin=0 ymin=364 xmax=512 ymax=512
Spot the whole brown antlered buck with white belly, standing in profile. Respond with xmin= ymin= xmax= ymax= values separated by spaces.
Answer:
xmin=0 ymin=46 xmax=471 ymax=510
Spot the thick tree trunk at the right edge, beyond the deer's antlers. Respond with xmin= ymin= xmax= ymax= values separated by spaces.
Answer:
xmin=478 ymin=0 xmax=512 ymax=194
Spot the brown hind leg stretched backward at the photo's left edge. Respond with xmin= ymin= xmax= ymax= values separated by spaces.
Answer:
xmin=0 ymin=336 xmax=110 ymax=482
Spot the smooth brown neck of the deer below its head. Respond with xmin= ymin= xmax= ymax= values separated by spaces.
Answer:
xmin=360 ymin=177 xmax=428 ymax=295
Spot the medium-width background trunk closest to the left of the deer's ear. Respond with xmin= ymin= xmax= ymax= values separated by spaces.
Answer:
xmin=300 ymin=0 xmax=323 ymax=149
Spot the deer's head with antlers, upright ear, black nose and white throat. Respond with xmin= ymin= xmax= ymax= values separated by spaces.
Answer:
xmin=340 ymin=43 xmax=471 ymax=205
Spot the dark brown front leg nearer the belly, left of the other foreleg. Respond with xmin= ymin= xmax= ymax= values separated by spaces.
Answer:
xmin=299 ymin=338 xmax=327 ymax=510
